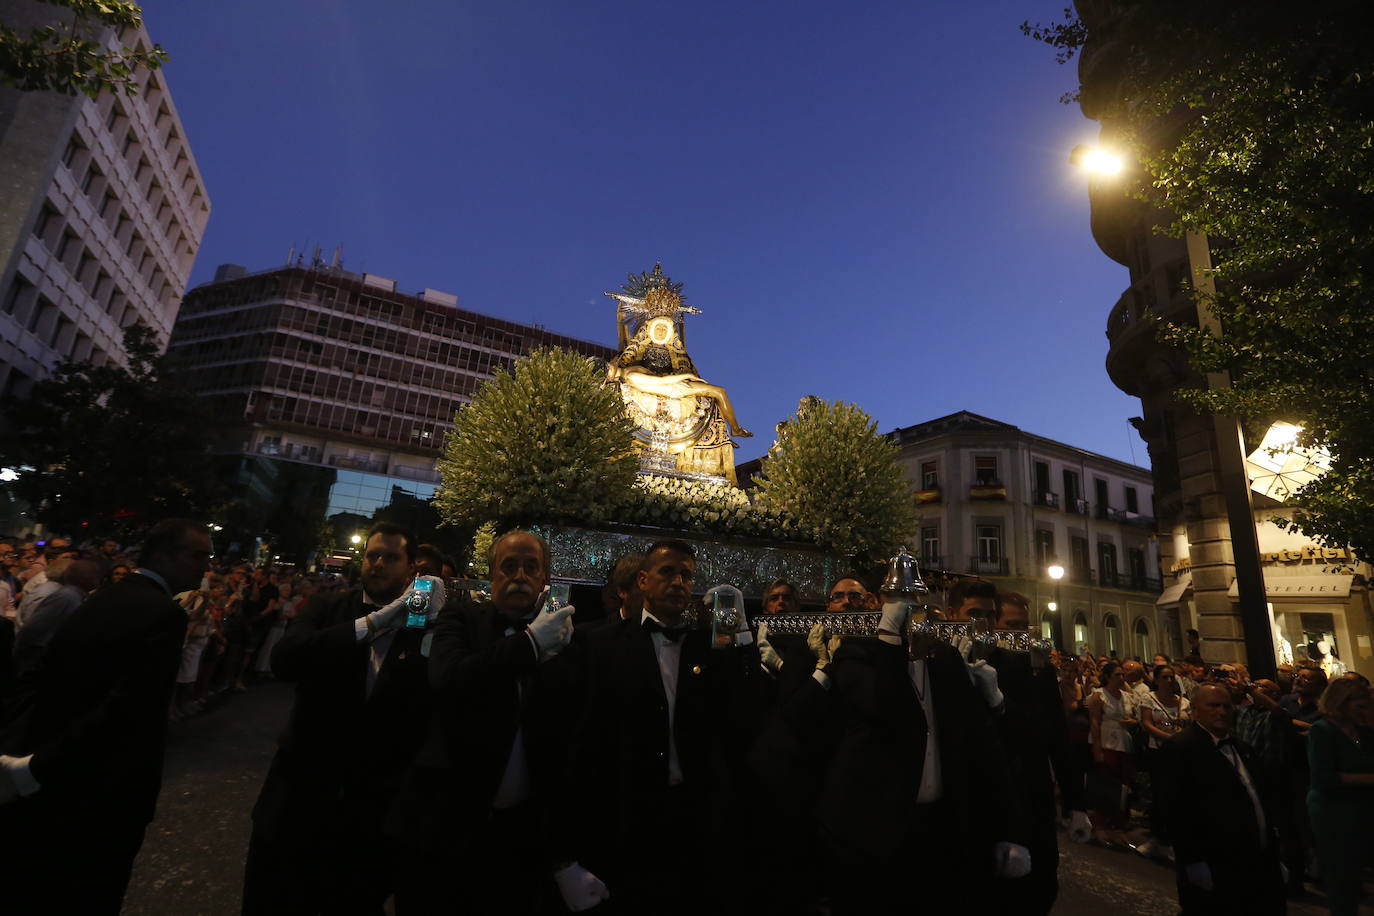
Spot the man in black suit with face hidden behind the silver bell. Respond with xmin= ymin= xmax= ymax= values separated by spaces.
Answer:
xmin=752 ymin=580 xmax=1029 ymax=916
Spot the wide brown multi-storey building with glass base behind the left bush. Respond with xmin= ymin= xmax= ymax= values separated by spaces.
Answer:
xmin=168 ymin=254 xmax=616 ymax=559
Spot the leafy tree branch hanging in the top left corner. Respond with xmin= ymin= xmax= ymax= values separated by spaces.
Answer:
xmin=0 ymin=0 xmax=168 ymax=99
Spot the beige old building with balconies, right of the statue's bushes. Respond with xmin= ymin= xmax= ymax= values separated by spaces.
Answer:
xmin=738 ymin=411 xmax=1182 ymax=661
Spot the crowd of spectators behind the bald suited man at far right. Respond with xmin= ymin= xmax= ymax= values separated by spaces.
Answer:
xmin=1051 ymin=643 xmax=1374 ymax=912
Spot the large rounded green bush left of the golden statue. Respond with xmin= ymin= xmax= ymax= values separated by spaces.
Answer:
xmin=434 ymin=349 xmax=639 ymax=527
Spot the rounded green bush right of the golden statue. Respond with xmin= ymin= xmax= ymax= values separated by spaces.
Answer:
xmin=758 ymin=398 xmax=916 ymax=559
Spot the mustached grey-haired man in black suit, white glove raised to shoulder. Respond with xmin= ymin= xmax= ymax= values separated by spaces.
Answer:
xmin=389 ymin=530 xmax=606 ymax=916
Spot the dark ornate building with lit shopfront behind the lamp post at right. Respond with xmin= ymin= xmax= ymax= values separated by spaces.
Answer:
xmin=1076 ymin=3 xmax=1374 ymax=676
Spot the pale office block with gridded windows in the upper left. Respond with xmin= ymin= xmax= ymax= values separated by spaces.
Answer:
xmin=0 ymin=3 xmax=210 ymax=397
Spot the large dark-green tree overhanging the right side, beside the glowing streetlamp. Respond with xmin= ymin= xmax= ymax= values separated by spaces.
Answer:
xmin=1032 ymin=0 xmax=1374 ymax=558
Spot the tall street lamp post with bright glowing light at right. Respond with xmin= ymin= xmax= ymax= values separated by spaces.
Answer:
xmin=1061 ymin=144 xmax=1278 ymax=677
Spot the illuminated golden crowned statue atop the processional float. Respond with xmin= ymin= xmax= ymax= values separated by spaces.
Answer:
xmin=606 ymin=264 xmax=752 ymax=483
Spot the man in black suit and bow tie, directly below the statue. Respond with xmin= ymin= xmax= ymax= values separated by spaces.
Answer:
xmin=565 ymin=541 xmax=758 ymax=916
